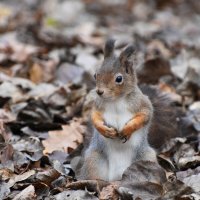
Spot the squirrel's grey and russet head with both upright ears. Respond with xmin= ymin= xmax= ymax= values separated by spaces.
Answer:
xmin=94 ymin=39 xmax=137 ymax=101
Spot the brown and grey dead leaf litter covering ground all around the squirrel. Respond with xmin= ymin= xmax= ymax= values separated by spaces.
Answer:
xmin=0 ymin=0 xmax=200 ymax=200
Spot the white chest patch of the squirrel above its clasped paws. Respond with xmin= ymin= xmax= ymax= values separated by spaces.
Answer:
xmin=103 ymin=100 xmax=133 ymax=130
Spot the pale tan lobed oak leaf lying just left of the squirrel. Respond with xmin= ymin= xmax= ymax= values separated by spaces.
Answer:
xmin=42 ymin=120 xmax=85 ymax=154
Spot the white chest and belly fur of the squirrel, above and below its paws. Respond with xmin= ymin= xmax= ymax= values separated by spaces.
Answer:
xmin=103 ymin=101 xmax=145 ymax=181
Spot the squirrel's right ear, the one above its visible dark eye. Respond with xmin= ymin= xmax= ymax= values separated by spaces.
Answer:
xmin=119 ymin=45 xmax=136 ymax=72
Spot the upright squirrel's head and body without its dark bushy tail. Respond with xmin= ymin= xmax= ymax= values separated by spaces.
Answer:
xmin=72 ymin=39 xmax=178 ymax=181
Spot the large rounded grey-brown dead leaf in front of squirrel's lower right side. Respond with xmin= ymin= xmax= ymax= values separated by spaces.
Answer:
xmin=117 ymin=161 xmax=167 ymax=200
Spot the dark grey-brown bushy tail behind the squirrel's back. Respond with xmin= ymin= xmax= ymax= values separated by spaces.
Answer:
xmin=140 ymin=85 xmax=179 ymax=149
